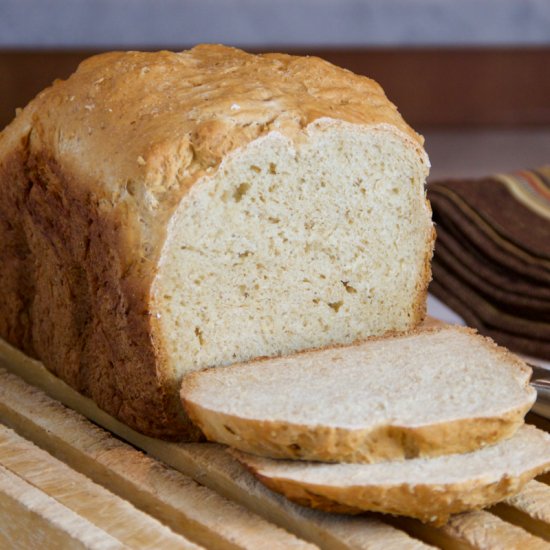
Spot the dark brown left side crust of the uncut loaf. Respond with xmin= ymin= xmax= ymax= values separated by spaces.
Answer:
xmin=0 ymin=112 xmax=197 ymax=440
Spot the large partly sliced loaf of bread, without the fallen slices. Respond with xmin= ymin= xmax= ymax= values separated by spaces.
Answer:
xmin=0 ymin=46 xmax=433 ymax=439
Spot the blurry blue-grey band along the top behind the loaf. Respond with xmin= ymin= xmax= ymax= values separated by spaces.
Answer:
xmin=0 ymin=0 xmax=550 ymax=48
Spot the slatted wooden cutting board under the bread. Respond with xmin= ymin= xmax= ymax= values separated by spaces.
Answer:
xmin=0 ymin=340 xmax=550 ymax=550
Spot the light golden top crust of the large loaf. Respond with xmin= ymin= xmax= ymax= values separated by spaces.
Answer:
xmin=0 ymin=45 xmax=428 ymax=257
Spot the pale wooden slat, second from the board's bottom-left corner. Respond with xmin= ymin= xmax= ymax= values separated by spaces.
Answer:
xmin=0 ymin=425 xmax=199 ymax=550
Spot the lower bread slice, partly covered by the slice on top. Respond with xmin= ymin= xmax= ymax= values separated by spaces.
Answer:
xmin=231 ymin=425 xmax=550 ymax=524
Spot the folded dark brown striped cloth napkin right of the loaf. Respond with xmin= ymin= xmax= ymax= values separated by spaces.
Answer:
xmin=428 ymin=166 xmax=550 ymax=359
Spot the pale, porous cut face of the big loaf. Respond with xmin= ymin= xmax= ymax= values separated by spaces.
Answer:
xmin=153 ymin=119 xmax=432 ymax=378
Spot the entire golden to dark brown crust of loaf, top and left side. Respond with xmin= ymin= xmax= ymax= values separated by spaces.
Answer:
xmin=0 ymin=46 xmax=427 ymax=439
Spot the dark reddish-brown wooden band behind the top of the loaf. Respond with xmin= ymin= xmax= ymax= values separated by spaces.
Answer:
xmin=0 ymin=48 xmax=550 ymax=132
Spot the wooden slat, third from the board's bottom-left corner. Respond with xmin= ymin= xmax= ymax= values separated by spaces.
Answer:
xmin=0 ymin=370 xmax=312 ymax=550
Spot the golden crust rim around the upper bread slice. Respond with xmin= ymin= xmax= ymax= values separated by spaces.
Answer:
xmin=180 ymin=327 xmax=536 ymax=463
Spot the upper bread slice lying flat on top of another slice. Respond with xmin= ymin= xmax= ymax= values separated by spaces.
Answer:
xmin=181 ymin=326 xmax=536 ymax=462
